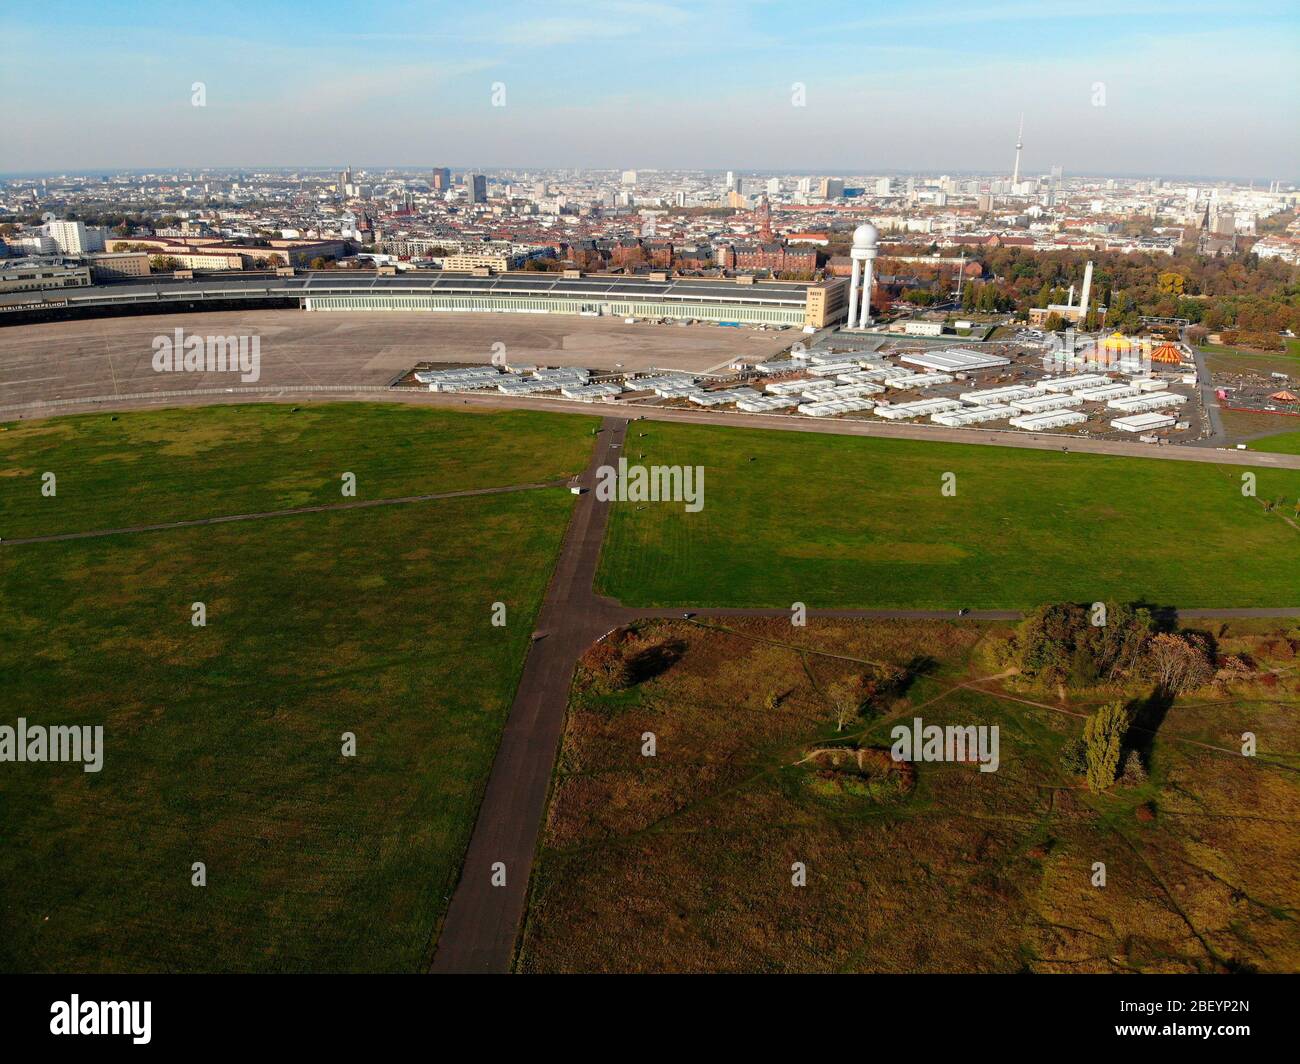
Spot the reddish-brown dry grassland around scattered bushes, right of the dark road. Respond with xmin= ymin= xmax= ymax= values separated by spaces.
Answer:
xmin=519 ymin=620 xmax=1300 ymax=972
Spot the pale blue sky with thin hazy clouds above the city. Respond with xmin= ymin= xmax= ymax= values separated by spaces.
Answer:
xmin=0 ymin=0 xmax=1300 ymax=181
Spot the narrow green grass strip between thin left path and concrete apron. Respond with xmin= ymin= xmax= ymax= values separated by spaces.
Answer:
xmin=0 ymin=403 xmax=594 ymax=539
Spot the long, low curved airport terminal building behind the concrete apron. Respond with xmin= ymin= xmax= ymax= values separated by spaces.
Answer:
xmin=0 ymin=272 xmax=848 ymax=329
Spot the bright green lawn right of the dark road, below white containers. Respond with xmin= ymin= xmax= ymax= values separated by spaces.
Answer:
xmin=598 ymin=423 xmax=1300 ymax=609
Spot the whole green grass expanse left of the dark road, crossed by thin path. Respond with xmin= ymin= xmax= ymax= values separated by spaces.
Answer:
xmin=0 ymin=406 xmax=590 ymax=972
